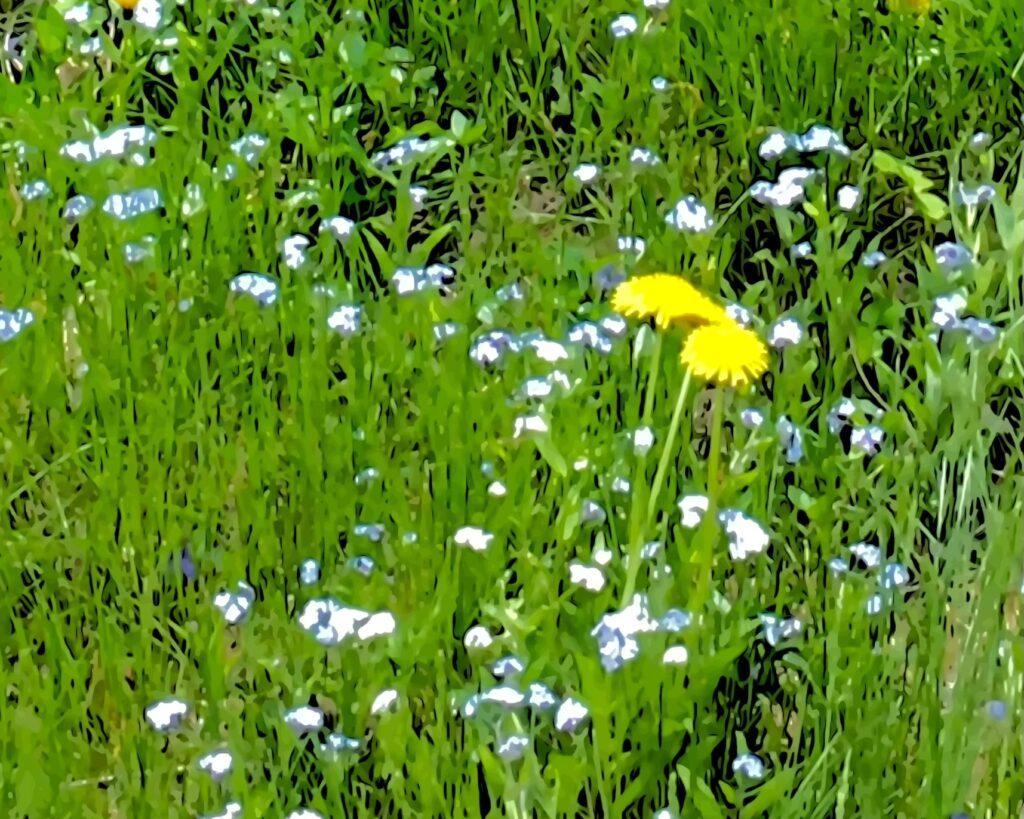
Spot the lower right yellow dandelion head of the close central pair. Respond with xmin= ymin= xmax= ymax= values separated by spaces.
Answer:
xmin=679 ymin=319 xmax=768 ymax=387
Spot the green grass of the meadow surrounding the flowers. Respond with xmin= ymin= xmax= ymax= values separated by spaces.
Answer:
xmin=0 ymin=0 xmax=1024 ymax=819
